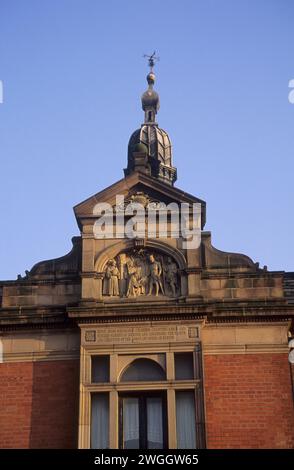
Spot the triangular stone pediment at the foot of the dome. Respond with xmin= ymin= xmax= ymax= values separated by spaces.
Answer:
xmin=74 ymin=172 xmax=206 ymax=229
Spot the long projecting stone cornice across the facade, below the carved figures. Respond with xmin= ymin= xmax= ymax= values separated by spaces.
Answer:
xmin=0 ymin=299 xmax=294 ymax=331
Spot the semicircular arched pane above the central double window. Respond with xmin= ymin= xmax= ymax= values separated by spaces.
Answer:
xmin=121 ymin=358 xmax=166 ymax=382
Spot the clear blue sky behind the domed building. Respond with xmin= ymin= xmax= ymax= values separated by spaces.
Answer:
xmin=0 ymin=0 xmax=294 ymax=279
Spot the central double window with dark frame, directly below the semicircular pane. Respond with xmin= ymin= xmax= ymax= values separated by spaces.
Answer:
xmin=120 ymin=392 xmax=166 ymax=449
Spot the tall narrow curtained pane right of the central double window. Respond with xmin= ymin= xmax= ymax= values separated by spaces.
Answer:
xmin=176 ymin=391 xmax=196 ymax=449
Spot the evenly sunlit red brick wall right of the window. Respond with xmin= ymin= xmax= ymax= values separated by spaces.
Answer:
xmin=204 ymin=354 xmax=294 ymax=448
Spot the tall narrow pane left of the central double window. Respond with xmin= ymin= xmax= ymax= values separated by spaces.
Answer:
xmin=91 ymin=393 xmax=109 ymax=449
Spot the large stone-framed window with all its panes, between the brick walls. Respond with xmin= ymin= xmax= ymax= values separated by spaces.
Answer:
xmin=79 ymin=343 xmax=206 ymax=450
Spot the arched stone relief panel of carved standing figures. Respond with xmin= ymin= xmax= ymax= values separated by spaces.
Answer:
xmin=103 ymin=249 xmax=180 ymax=298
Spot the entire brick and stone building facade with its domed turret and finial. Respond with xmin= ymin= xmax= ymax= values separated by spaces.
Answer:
xmin=0 ymin=64 xmax=294 ymax=449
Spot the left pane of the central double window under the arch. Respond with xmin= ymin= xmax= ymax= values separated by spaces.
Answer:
xmin=123 ymin=397 xmax=140 ymax=449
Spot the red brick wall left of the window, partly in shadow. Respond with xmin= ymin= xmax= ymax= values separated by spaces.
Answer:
xmin=0 ymin=360 xmax=79 ymax=448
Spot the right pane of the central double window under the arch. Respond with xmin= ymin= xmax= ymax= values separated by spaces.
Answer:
xmin=146 ymin=397 xmax=163 ymax=449
